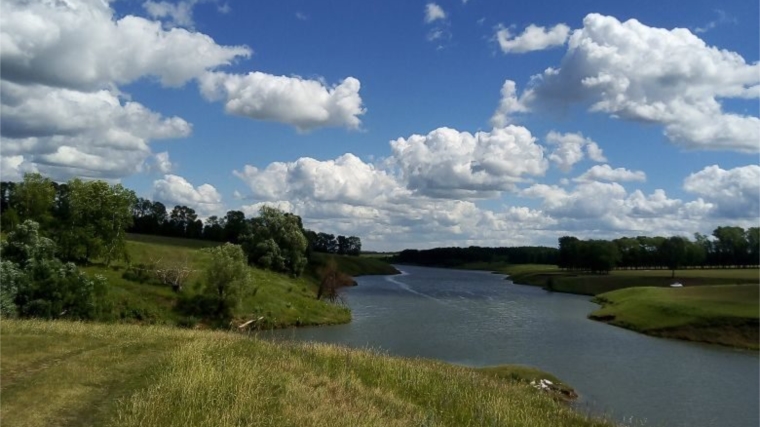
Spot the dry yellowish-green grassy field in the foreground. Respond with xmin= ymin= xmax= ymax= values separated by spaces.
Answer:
xmin=0 ymin=320 xmax=612 ymax=427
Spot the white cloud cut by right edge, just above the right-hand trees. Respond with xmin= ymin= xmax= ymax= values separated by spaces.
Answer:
xmin=683 ymin=165 xmax=760 ymax=217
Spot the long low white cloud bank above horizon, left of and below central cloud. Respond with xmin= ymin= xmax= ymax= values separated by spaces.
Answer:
xmin=235 ymin=154 xmax=554 ymax=249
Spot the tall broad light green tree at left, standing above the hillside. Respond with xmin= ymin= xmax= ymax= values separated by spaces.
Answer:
xmin=69 ymin=179 xmax=137 ymax=265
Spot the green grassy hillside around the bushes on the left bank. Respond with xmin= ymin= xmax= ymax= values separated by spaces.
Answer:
xmin=78 ymin=235 xmax=351 ymax=328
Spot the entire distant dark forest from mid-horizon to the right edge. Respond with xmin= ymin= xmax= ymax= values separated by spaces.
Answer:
xmin=393 ymin=226 xmax=760 ymax=273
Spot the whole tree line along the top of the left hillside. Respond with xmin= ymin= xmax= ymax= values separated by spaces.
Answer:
xmin=0 ymin=174 xmax=361 ymax=275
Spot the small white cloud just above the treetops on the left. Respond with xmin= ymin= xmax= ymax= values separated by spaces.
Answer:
xmin=152 ymin=174 xmax=224 ymax=217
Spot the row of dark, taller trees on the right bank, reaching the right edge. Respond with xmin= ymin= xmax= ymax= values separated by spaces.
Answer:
xmin=557 ymin=226 xmax=760 ymax=273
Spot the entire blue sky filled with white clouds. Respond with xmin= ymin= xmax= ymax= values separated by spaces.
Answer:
xmin=0 ymin=0 xmax=760 ymax=251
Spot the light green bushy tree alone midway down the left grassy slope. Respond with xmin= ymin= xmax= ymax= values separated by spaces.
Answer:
xmin=204 ymin=243 xmax=249 ymax=317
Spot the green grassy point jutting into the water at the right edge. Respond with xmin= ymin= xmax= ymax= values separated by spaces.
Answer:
xmin=589 ymin=284 xmax=760 ymax=349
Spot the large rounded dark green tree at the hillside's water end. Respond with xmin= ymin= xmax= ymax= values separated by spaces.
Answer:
xmin=241 ymin=206 xmax=308 ymax=276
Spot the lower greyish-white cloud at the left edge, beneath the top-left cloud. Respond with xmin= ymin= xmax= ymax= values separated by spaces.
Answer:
xmin=0 ymin=81 xmax=192 ymax=180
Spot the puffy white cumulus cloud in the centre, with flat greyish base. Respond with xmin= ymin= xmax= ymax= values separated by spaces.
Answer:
xmin=391 ymin=126 xmax=548 ymax=198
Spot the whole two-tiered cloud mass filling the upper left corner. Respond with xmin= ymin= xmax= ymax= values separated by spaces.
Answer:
xmin=0 ymin=0 xmax=250 ymax=180
